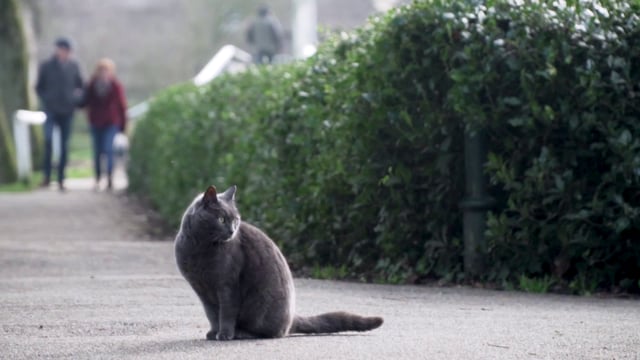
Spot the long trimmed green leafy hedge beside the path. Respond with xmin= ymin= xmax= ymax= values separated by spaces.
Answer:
xmin=130 ymin=1 xmax=640 ymax=292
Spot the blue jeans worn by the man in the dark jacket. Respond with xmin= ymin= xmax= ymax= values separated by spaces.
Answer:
xmin=43 ymin=112 xmax=73 ymax=184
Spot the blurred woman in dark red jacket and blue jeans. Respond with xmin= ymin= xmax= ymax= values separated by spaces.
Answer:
xmin=85 ymin=59 xmax=127 ymax=190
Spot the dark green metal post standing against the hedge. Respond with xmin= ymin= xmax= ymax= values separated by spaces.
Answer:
xmin=460 ymin=129 xmax=494 ymax=279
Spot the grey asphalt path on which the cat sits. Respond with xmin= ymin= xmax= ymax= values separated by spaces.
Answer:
xmin=0 ymin=182 xmax=640 ymax=360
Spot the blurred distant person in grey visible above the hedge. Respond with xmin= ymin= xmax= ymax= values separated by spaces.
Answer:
xmin=247 ymin=6 xmax=283 ymax=64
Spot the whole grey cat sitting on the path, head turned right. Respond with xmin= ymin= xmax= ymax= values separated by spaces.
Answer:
xmin=175 ymin=186 xmax=383 ymax=340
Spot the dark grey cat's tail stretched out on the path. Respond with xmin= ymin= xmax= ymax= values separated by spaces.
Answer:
xmin=289 ymin=311 xmax=384 ymax=334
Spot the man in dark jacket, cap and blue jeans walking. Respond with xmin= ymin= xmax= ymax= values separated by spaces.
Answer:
xmin=36 ymin=38 xmax=83 ymax=191
